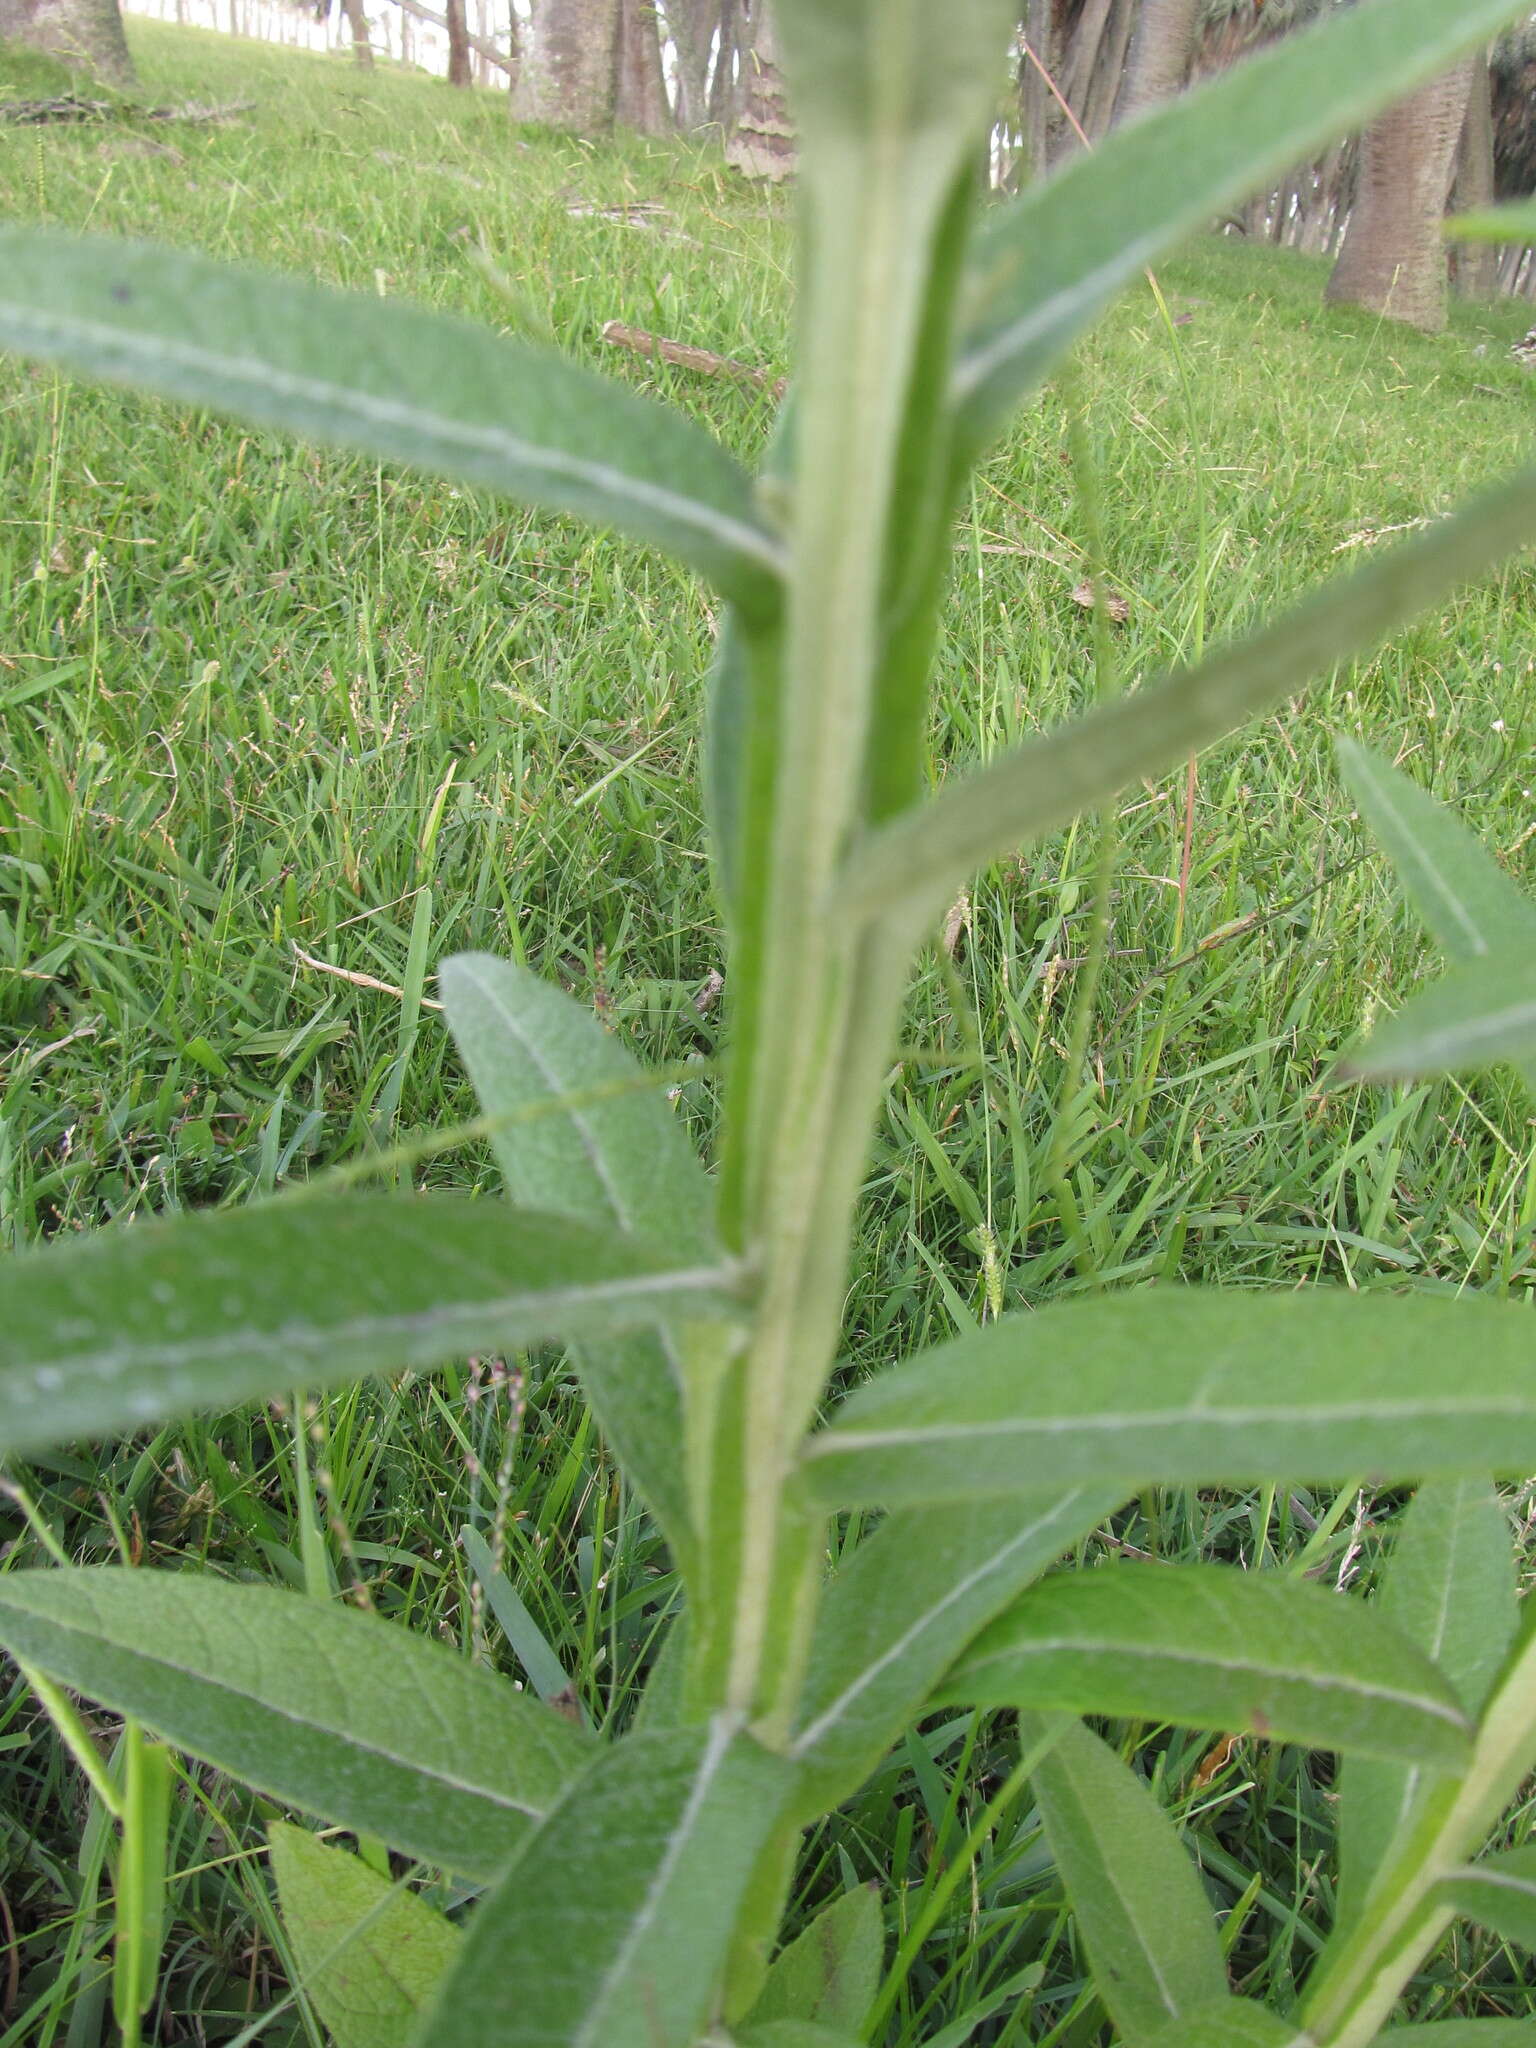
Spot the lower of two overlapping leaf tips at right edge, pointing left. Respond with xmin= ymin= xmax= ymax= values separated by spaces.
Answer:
xmin=1337 ymin=950 xmax=1536 ymax=1081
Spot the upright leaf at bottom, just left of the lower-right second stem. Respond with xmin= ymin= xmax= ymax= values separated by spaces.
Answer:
xmin=1024 ymin=1722 xmax=1227 ymax=2042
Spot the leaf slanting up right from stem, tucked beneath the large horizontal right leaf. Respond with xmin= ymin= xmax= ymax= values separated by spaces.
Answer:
xmin=791 ymin=1485 xmax=1124 ymax=1812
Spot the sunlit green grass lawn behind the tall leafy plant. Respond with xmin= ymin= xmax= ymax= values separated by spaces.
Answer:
xmin=0 ymin=23 xmax=1536 ymax=2048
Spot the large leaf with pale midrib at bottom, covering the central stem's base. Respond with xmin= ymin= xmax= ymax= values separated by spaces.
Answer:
xmin=416 ymin=1718 xmax=793 ymax=2048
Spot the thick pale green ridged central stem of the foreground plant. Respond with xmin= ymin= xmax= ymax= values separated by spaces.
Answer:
xmin=713 ymin=135 xmax=966 ymax=1739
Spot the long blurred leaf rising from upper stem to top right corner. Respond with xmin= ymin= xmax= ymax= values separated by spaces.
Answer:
xmin=954 ymin=0 xmax=1524 ymax=449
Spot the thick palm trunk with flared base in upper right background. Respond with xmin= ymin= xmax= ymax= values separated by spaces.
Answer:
xmin=1325 ymin=61 xmax=1473 ymax=334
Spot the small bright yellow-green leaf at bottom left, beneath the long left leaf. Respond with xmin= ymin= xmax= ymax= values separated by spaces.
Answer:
xmin=268 ymin=1821 xmax=463 ymax=2048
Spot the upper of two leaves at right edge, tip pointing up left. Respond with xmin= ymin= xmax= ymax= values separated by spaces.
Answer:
xmin=1333 ymin=737 xmax=1536 ymax=963
